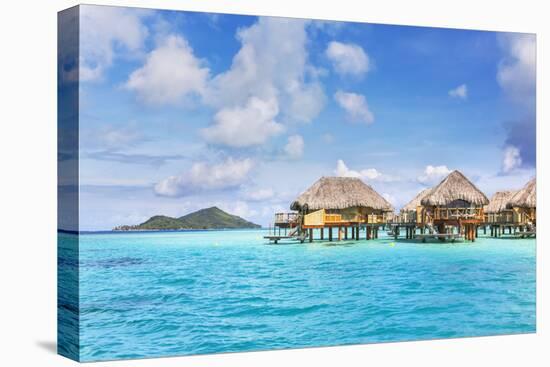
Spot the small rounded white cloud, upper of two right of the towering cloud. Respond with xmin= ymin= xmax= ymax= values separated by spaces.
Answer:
xmin=325 ymin=41 xmax=370 ymax=76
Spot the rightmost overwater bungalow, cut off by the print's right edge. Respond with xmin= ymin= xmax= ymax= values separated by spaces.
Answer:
xmin=506 ymin=178 xmax=537 ymax=233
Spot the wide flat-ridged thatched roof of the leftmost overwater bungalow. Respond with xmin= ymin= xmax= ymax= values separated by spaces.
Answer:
xmin=290 ymin=177 xmax=393 ymax=211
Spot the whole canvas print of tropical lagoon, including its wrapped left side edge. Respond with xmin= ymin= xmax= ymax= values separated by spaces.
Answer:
xmin=58 ymin=5 xmax=537 ymax=361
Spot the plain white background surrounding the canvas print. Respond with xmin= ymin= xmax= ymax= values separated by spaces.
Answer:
xmin=0 ymin=0 xmax=550 ymax=367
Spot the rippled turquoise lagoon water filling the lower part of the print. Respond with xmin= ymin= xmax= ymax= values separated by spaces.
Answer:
xmin=60 ymin=230 xmax=536 ymax=361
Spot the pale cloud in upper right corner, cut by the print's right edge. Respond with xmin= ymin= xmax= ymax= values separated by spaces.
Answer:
xmin=497 ymin=33 xmax=537 ymax=102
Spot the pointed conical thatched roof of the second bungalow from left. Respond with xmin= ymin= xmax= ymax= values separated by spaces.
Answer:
xmin=421 ymin=170 xmax=489 ymax=206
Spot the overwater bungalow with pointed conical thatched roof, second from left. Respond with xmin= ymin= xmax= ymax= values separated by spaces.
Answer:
xmin=417 ymin=170 xmax=489 ymax=241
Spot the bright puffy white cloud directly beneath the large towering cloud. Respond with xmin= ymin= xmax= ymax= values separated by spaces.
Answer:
xmin=205 ymin=97 xmax=284 ymax=148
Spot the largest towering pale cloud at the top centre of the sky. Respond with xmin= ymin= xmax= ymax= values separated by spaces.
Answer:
xmin=205 ymin=17 xmax=325 ymax=122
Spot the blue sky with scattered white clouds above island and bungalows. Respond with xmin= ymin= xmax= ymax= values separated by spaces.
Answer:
xmin=71 ymin=5 xmax=535 ymax=230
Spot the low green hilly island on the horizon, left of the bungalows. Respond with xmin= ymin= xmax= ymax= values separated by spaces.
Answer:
xmin=114 ymin=206 xmax=260 ymax=231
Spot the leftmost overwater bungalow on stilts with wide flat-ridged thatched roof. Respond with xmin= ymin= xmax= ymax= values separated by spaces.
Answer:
xmin=266 ymin=177 xmax=393 ymax=242
